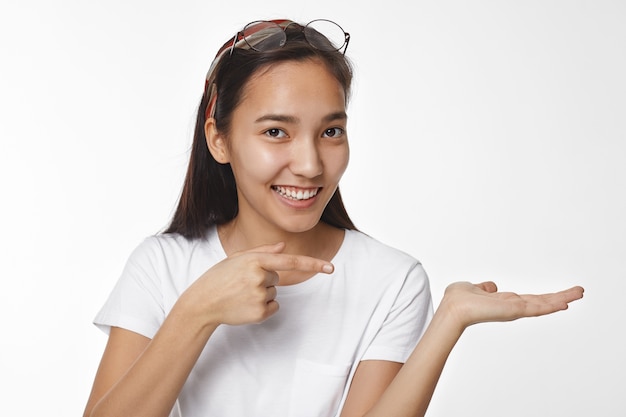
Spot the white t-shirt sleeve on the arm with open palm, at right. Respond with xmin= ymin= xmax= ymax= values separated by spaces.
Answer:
xmin=361 ymin=262 xmax=433 ymax=363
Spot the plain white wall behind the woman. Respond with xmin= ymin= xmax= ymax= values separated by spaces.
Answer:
xmin=0 ymin=0 xmax=626 ymax=417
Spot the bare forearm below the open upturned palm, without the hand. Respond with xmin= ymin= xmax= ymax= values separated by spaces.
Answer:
xmin=366 ymin=300 xmax=464 ymax=417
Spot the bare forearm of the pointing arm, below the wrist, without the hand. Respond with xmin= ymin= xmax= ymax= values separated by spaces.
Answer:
xmin=89 ymin=306 xmax=217 ymax=417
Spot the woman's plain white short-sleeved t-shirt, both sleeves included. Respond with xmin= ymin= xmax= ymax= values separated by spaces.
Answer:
xmin=94 ymin=228 xmax=432 ymax=417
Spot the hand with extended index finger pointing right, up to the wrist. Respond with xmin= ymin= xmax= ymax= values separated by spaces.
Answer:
xmin=177 ymin=243 xmax=333 ymax=326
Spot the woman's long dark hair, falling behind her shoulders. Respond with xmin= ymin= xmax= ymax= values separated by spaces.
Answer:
xmin=164 ymin=25 xmax=356 ymax=239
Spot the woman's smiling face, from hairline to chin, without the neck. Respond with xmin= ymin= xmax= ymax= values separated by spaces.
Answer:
xmin=214 ymin=61 xmax=349 ymax=233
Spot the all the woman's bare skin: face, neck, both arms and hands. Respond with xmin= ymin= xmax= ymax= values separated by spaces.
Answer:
xmin=84 ymin=61 xmax=583 ymax=417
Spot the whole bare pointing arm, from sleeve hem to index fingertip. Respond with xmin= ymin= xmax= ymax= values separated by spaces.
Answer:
xmin=85 ymin=243 xmax=333 ymax=416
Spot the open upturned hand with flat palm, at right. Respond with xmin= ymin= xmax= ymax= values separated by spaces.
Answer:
xmin=440 ymin=281 xmax=584 ymax=328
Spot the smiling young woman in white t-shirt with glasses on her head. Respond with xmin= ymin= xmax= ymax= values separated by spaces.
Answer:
xmin=85 ymin=20 xmax=582 ymax=417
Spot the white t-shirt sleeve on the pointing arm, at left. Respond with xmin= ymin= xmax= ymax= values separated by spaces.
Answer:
xmin=94 ymin=238 xmax=165 ymax=338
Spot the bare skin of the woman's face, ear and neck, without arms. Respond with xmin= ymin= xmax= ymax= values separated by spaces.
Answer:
xmin=205 ymin=61 xmax=349 ymax=285
